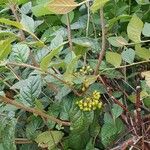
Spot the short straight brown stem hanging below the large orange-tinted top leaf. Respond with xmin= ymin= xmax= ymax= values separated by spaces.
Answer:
xmin=66 ymin=14 xmax=73 ymax=51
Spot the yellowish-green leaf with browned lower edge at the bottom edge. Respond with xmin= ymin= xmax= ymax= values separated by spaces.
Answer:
xmin=35 ymin=131 xmax=64 ymax=150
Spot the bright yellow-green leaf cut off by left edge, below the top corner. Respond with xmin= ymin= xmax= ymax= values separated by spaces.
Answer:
xmin=0 ymin=39 xmax=13 ymax=60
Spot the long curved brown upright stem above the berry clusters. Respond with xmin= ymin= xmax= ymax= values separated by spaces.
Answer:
xmin=94 ymin=7 xmax=106 ymax=75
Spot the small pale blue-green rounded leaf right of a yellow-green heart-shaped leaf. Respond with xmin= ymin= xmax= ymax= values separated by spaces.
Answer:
xmin=121 ymin=48 xmax=135 ymax=64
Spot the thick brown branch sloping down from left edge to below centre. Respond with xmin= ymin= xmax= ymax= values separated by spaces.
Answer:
xmin=0 ymin=96 xmax=71 ymax=126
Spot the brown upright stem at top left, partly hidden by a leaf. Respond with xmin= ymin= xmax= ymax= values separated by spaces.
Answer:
xmin=9 ymin=4 xmax=25 ymax=41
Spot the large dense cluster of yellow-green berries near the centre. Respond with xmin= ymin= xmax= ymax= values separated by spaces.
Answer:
xmin=76 ymin=91 xmax=102 ymax=111
